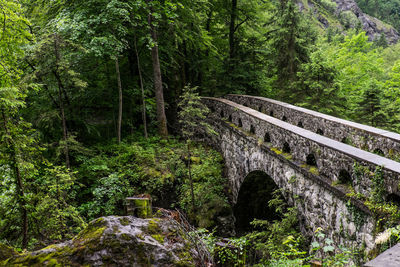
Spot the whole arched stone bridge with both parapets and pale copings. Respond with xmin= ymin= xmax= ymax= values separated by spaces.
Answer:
xmin=203 ymin=95 xmax=400 ymax=258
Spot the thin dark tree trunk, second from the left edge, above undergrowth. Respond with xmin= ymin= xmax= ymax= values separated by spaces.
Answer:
xmin=53 ymin=34 xmax=71 ymax=169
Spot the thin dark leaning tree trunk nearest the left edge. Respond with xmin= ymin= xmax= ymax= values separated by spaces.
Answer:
xmin=2 ymin=111 xmax=28 ymax=249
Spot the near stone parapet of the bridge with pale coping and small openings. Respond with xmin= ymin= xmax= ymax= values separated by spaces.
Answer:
xmin=203 ymin=98 xmax=400 ymax=200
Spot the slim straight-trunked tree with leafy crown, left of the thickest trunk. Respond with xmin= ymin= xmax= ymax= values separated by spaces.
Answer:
xmin=60 ymin=0 xmax=132 ymax=142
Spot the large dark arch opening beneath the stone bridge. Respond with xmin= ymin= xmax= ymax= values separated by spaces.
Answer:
xmin=233 ymin=171 xmax=283 ymax=235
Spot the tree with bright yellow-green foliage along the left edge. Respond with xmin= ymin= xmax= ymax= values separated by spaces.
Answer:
xmin=0 ymin=0 xmax=31 ymax=248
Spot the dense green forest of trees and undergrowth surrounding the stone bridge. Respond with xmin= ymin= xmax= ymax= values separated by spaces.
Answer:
xmin=0 ymin=0 xmax=400 ymax=264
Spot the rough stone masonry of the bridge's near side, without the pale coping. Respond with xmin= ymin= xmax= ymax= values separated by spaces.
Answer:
xmin=205 ymin=99 xmax=375 ymax=255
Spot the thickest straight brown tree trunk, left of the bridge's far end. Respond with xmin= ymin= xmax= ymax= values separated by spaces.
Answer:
xmin=146 ymin=0 xmax=168 ymax=138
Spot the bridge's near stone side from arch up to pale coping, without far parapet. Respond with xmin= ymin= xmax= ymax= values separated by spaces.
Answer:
xmin=204 ymin=98 xmax=400 ymax=253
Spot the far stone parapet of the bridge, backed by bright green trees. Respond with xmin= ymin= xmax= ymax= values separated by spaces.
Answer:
xmin=225 ymin=95 xmax=400 ymax=160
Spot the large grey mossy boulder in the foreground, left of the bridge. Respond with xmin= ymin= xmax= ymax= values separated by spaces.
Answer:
xmin=0 ymin=216 xmax=197 ymax=266
